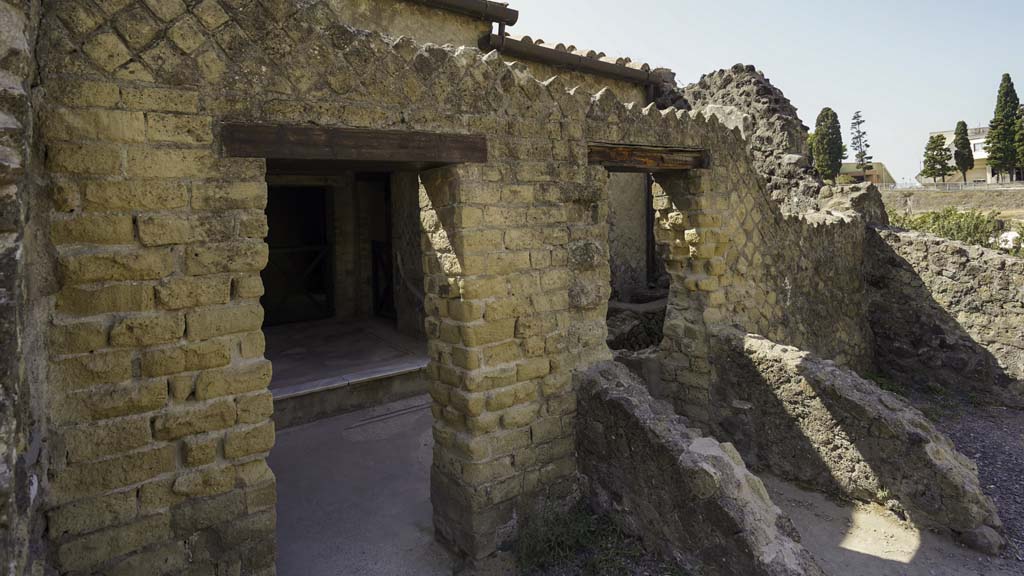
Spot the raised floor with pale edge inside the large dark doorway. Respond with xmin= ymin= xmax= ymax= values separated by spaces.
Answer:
xmin=264 ymin=319 xmax=428 ymax=399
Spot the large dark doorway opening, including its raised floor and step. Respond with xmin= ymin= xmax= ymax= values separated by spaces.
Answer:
xmin=262 ymin=165 xmax=427 ymax=428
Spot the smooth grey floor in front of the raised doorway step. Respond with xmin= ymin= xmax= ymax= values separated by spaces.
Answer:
xmin=268 ymin=396 xmax=456 ymax=576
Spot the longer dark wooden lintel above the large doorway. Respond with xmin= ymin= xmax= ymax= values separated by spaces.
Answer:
xmin=220 ymin=123 xmax=487 ymax=166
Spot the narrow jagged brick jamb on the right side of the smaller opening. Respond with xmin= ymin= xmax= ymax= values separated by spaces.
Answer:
xmin=654 ymin=173 xmax=729 ymax=425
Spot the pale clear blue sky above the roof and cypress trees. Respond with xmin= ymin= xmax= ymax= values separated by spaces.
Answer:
xmin=507 ymin=0 xmax=1024 ymax=181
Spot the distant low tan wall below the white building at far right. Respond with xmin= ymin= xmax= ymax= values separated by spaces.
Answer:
xmin=882 ymin=187 xmax=1024 ymax=220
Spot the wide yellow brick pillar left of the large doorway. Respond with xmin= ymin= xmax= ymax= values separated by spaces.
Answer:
xmin=42 ymin=80 xmax=274 ymax=575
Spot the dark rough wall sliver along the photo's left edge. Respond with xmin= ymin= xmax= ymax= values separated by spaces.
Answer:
xmin=0 ymin=0 xmax=45 ymax=574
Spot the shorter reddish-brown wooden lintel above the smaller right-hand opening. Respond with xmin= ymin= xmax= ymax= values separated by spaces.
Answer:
xmin=588 ymin=142 xmax=711 ymax=173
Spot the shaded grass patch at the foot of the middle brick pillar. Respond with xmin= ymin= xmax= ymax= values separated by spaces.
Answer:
xmin=514 ymin=502 xmax=687 ymax=576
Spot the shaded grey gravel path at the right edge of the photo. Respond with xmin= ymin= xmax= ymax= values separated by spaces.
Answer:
xmin=930 ymin=404 xmax=1024 ymax=562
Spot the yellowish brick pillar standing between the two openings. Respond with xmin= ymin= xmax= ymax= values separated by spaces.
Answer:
xmin=421 ymin=155 xmax=575 ymax=558
